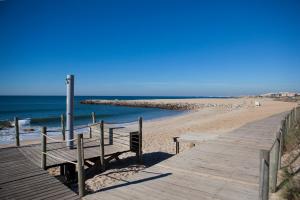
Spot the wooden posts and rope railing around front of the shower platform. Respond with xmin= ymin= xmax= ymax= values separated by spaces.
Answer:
xmin=37 ymin=117 xmax=143 ymax=197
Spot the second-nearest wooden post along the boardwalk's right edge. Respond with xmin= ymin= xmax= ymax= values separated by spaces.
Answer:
xmin=270 ymin=131 xmax=281 ymax=193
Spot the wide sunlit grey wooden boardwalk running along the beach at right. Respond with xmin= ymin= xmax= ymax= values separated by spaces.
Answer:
xmin=84 ymin=113 xmax=286 ymax=200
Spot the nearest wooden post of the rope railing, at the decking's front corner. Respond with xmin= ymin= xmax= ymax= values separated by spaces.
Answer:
xmin=77 ymin=134 xmax=85 ymax=198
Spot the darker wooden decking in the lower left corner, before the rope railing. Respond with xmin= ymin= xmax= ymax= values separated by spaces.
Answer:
xmin=0 ymin=147 xmax=79 ymax=200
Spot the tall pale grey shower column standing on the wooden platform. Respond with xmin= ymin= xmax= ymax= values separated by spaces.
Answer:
xmin=66 ymin=75 xmax=74 ymax=149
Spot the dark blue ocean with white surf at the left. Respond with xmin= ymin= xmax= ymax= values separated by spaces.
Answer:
xmin=0 ymin=96 xmax=193 ymax=144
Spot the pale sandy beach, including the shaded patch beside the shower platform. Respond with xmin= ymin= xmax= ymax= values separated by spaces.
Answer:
xmin=82 ymin=97 xmax=297 ymax=192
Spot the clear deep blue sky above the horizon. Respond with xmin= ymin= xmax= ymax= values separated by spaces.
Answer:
xmin=0 ymin=0 xmax=300 ymax=96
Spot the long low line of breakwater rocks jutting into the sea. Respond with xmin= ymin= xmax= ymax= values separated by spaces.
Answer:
xmin=80 ymin=100 xmax=241 ymax=110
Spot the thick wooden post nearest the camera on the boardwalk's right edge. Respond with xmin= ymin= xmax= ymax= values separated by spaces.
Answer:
xmin=259 ymin=150 xmax=270 ymax=200
